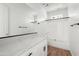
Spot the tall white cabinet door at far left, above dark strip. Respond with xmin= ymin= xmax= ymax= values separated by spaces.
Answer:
xmin=0 ymin=3 xmax=8 ymax=37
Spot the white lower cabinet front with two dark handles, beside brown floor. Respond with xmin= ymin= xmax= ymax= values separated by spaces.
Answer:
xmin=20 ymin=40 xmax=47 ymax=56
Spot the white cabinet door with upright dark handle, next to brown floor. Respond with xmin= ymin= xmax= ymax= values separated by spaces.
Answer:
xmin=32 ymin=40 xmax=47 ymax=56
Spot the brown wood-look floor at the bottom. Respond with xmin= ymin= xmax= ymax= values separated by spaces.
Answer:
xmin=48 ymin=46 xmax=71 ymax=56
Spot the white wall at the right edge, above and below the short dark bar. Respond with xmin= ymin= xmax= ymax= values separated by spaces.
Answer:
xmin=68 ymin=3 xmax=79 ymax=56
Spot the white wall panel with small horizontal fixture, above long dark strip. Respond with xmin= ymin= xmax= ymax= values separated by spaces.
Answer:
xmin=7 ymin=3 xmax=33 ymax=35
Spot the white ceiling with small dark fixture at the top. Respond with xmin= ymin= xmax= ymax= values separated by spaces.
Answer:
xmin=26 ymin=3 xmax=66 ymax=12
